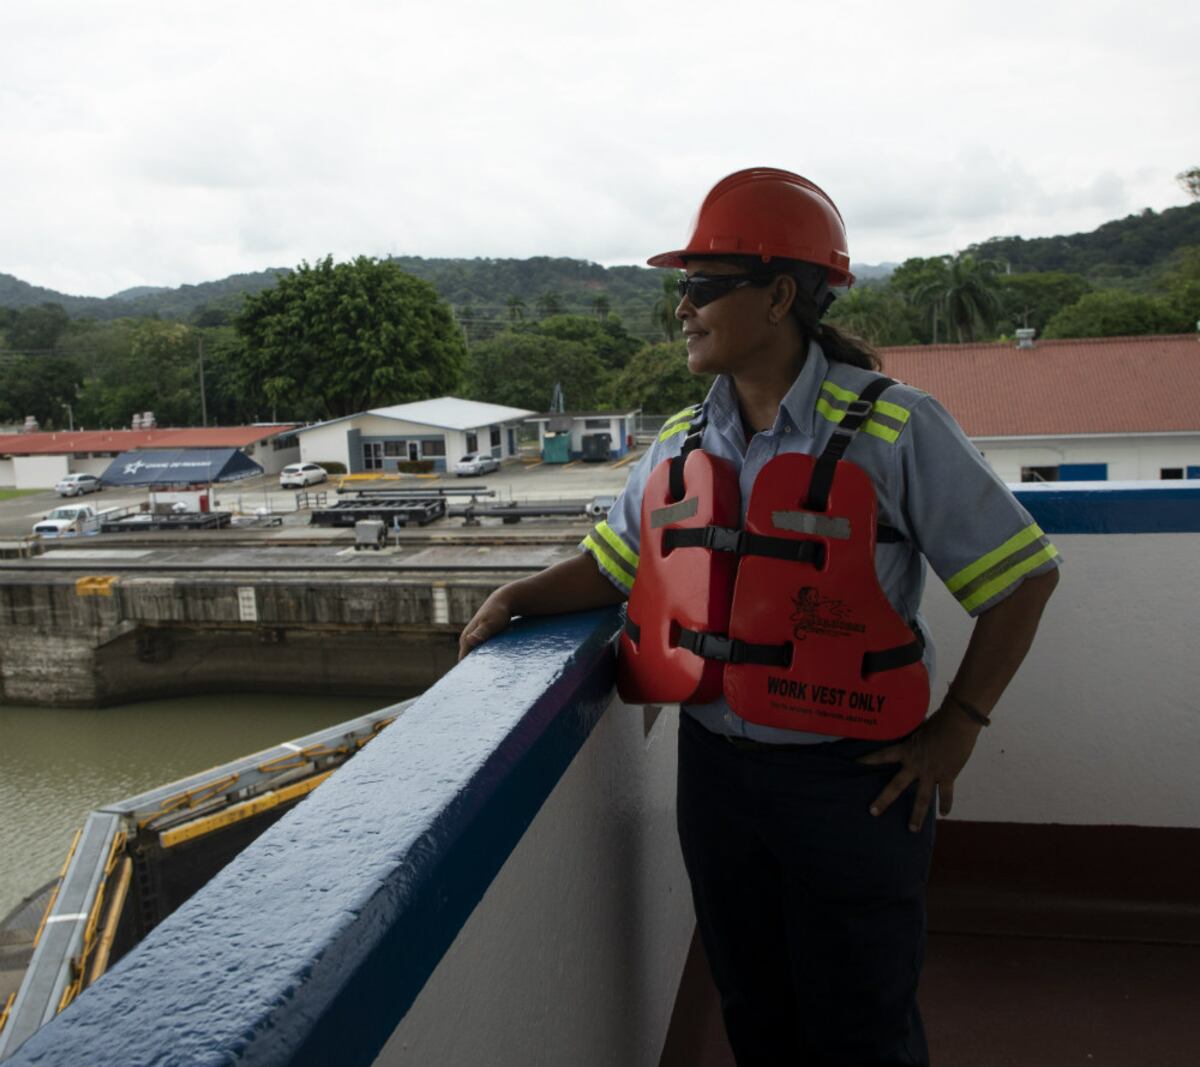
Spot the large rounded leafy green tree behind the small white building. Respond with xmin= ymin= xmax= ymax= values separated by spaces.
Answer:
xmin=234 ymin=256 xmax=466 ymax=420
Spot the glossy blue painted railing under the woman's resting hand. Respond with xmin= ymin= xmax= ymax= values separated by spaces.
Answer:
xmin=6 ymin=610 xmax=618 ymax=1067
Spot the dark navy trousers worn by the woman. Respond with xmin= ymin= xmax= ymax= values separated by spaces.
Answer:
xmin=678 ymin=714 xmax=934 ymax=1067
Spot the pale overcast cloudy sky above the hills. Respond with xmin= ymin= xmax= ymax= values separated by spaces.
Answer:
xmin=0 ymin=0 xmax=1200 ymax=295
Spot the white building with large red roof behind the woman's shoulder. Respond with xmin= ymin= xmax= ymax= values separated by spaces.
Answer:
xmin=881 ymin=334 xmax=1200 ymax=482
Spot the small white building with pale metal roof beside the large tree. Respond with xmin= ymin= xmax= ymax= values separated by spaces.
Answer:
xmin=296 ymin=396 xmax=534 ymax=474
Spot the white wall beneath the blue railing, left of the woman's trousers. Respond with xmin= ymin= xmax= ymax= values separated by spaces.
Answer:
xmin=376 ymin=701 xmax=695 ymax=1067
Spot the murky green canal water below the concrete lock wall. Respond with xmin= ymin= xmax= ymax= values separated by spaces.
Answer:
xmin=0 ymin=693 xmax=412 ymax=918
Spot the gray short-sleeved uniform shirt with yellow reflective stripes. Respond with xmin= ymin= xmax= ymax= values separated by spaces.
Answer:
xmin=581 ymin=342 xmax=1060 ymax=744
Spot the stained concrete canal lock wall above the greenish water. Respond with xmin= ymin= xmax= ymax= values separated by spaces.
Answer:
xmin=0 ymin=574 xmax=494 ymax=707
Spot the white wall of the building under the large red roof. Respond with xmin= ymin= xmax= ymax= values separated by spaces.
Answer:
xmin=976 ymin=433 xmax=1200 ymax=482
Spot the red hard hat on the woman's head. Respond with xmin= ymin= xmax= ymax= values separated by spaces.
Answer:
xmin=647 ymin=167 xmax=854 ymax=286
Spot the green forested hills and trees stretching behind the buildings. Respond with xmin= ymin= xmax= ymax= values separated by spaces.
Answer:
xmin=0 ymin=191 xmax=1200 ymax=428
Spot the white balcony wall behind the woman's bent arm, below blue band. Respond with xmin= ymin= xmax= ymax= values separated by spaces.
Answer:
xmin=923 ymin=533 xmax=1200 ymax=827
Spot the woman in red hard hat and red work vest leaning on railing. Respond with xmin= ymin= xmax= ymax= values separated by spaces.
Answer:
xmin=461 ymin=168 xmax=1058 ymax=1065
